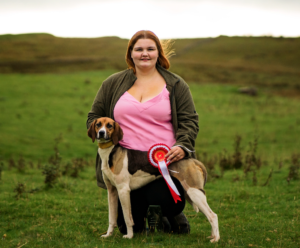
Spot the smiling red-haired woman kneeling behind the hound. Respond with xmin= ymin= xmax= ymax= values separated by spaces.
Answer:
xmin=87 ymin=30 xmax=199 ymax=232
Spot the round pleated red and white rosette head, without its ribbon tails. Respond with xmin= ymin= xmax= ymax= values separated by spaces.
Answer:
xmin=148 ymin=143 xmax=170 ymax=168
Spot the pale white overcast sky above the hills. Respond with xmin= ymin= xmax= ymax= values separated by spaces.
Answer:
xmin=0 ymin=0 xmax=300 ymax=39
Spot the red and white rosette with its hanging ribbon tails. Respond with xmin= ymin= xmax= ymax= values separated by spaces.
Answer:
xmin=148 ymin=143 xmax=181 ymax=203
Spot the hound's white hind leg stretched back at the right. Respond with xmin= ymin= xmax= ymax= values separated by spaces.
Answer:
xmin=187 ymin=188 xmax=220 ymax=243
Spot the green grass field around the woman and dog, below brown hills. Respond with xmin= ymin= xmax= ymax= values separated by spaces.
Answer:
xmin=0 ymin=70 xmax=300 ymax=248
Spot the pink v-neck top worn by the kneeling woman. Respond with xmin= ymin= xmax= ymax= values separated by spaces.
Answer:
xmin=114 ymin=87 xmax=176 ymax=151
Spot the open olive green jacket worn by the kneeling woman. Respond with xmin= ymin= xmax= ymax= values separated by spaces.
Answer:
xmin=86 ymin=65 xmax=199 ymax=188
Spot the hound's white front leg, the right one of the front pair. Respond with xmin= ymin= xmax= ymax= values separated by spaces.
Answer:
xmin=118 ymin=184 xmax=134 ymax=239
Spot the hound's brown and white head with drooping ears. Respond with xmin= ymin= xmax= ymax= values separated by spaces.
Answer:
xmin=87 ymin=117 xmax=123 ymax=145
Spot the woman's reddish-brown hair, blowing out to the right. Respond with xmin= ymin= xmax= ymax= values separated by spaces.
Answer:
xmin=125 ymin=30 xmax=175 ymax=73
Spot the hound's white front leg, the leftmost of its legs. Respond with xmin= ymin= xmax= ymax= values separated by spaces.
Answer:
xmin=102 ymin=179 xmax=118 ymax=238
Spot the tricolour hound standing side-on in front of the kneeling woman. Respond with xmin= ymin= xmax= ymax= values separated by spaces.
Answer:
xmin=88 ymin=117 xmax=220 ymax=242
